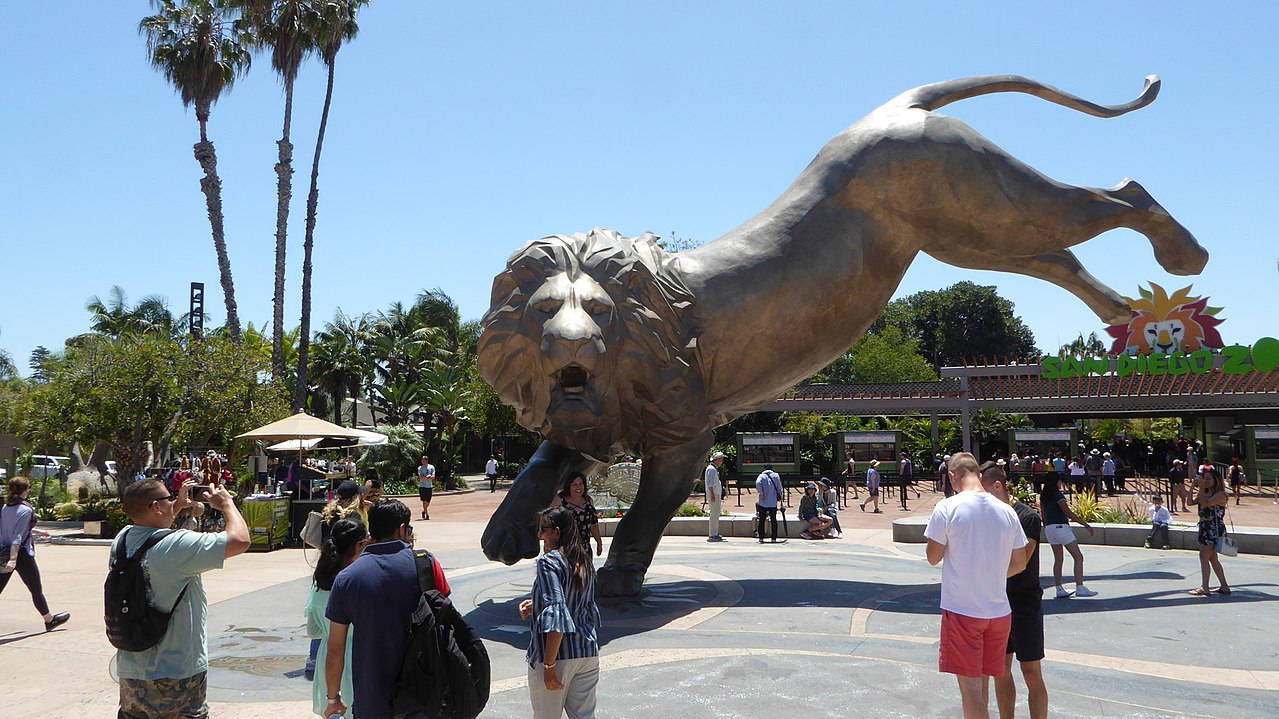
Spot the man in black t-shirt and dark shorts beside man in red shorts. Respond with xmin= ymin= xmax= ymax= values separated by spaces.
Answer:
xmin=981 ymin=463 xmax=1048 ymax=719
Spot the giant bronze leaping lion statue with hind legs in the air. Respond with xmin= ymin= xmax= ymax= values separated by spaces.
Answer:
xmin=480 ymin=75 xmax=1207 ymax=596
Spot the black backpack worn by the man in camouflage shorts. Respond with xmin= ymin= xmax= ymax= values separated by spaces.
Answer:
xmin=102 ymin=530 xmax=187 ymax=651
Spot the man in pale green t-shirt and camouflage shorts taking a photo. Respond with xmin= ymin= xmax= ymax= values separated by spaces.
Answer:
xmin=111 ymin=480 xmax=248 ymax=719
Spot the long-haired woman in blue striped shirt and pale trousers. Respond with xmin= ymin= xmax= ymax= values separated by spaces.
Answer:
xmin=519 ymin=507 xmax=600 ymax=719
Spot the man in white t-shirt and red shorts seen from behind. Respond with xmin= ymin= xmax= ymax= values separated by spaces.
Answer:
xmin=923 ymin=452 xmax=1030 ymax=719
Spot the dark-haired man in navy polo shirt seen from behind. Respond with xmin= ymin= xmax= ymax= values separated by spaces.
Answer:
xmin=324 ymin=499 xmax=449 ymax=719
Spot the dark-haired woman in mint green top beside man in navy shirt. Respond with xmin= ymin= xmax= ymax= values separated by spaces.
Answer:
xmin=306 ymin=517 xmax=368 ymax=716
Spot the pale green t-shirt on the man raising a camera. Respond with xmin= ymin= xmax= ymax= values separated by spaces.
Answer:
xmin=111 ymin=525 xmax=226 ymax=679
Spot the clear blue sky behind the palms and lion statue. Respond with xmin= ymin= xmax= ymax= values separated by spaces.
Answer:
xmin=0 ymin=0 xmax=1279 ymax=371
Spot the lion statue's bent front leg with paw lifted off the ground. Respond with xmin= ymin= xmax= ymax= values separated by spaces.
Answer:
xmin=480 ymin=441 xmax=595 ymax=564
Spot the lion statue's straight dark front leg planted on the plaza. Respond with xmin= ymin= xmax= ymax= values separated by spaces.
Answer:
xmin=595 ymin=432 xmax=711 ymax=596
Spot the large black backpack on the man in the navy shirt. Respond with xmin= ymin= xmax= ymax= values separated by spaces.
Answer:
xmin=395 ymin=551 xmax=490 ymax=719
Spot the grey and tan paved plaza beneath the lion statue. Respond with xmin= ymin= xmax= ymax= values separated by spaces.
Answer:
xmin=0 ymin=483 xmax=1279 ymax=719
